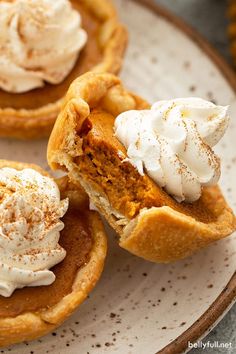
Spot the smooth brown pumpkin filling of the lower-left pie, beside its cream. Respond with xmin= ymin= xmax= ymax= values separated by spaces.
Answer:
xmin=0 ymin=208 xmax=93 ymax=318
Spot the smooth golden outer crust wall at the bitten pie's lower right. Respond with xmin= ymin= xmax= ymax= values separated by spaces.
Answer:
xmin=120 ymin=196 xmax=236 ymax=263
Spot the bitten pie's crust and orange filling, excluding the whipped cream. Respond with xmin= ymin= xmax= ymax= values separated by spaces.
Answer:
xmin=48 ymin=73 xmax=235 ymax=262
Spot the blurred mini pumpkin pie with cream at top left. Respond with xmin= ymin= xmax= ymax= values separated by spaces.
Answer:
xmin=0 ymin=0 xmax=127 ymax=139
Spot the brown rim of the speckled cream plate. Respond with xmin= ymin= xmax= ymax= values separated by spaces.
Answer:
xmin=131 ymin=0 xmax=236 ymax=354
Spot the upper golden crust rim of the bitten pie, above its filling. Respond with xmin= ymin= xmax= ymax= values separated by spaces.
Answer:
xmin=47 ymin=72 xmax=149 ymax=170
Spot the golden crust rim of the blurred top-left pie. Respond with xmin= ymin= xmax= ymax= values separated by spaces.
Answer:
xmin=0 ymin=0 xmax=127 ymax=139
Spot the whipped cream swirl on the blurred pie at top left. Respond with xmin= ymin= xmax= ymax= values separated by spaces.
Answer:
xmin=0 ymin=0 xmax=87 ymax=93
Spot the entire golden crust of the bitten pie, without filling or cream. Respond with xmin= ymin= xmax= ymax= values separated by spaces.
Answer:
xmin=48 ymin=73 xmax=236 ymax=263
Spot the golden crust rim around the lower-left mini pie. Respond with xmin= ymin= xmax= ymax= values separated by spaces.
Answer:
xmin=0 ymin=160 xmax=107 ymax=347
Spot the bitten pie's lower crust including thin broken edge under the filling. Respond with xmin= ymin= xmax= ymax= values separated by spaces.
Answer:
xmin=70 ymin=174 xmax=236 ymax=263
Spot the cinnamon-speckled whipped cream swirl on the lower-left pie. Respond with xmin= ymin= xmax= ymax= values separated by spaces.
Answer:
xmin=0 ymin=168 xmax=68 ymax=297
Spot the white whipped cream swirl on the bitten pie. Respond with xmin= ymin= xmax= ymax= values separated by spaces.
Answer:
xmin=114 ymin=98 xmax=229 ymax=202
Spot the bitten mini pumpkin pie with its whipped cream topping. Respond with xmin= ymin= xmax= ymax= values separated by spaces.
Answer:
xmin=48 ymin=73 xmax=235 ymax=262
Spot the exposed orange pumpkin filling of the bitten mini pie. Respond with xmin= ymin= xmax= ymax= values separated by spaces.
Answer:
xmin=75 ymin=109 xmax=216 ymax=223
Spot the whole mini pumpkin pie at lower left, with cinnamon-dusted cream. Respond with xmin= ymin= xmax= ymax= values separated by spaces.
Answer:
xmin=0 ymin=160 xmax=107 ymax=346
